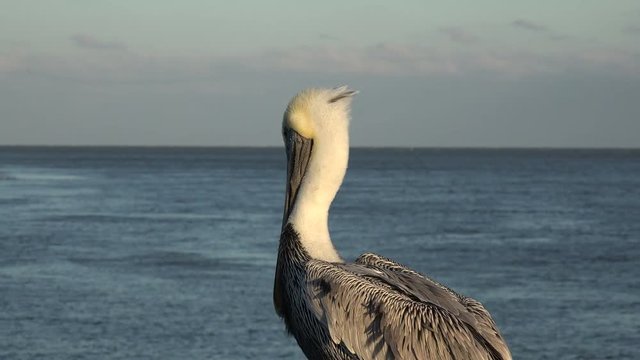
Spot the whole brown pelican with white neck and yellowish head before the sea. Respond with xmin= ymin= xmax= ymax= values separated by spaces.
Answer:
xmin=273 ymin=87 xmax=511 ymax=359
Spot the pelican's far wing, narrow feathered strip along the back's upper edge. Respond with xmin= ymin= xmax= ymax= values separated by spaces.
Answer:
xmin=355 ymin=253 xmax=511 ymax=359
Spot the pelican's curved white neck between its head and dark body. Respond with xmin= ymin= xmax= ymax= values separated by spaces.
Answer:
xmin=289 ymin=121 xmax=349 ymax=262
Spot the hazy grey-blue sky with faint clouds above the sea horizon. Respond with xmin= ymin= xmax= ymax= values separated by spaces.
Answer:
xmin=0 ymin=0 xmax=640 ymax=148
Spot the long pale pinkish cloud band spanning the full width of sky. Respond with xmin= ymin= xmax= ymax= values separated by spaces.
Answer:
xmin=5 ymin=43 xmax=640 ymax=84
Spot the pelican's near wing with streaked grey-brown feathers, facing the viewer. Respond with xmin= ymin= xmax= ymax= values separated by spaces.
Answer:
xmin=307 ymin=260 xmax=511 ymax=360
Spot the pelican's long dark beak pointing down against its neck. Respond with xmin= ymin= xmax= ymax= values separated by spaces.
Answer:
xmin=282 ymin=127 xmax=313 ymax=229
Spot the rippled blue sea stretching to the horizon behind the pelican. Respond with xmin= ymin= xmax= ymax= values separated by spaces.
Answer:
xmin=0 ymin=147 xmax=640 ymax=359
